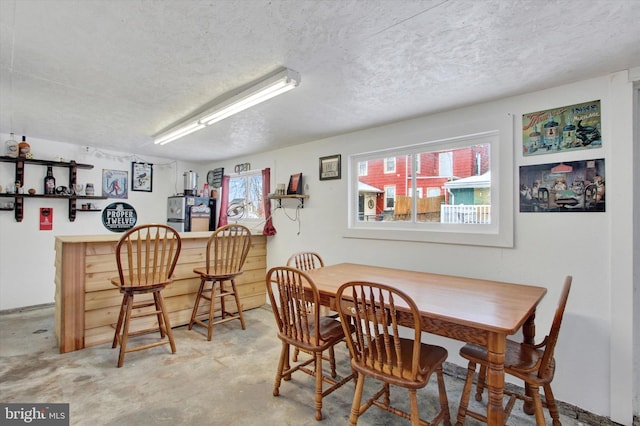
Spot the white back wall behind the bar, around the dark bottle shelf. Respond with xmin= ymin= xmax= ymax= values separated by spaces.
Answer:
xmin=0 ymin=138 xmax=198 ymax=310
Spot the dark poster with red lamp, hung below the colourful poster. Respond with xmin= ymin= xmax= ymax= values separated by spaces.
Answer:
xmin=520 ymin=158 xmax=606 ymax=212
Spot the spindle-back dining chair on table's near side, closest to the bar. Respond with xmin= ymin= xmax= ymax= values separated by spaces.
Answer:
xmin=266 ymin=266 xmax=353 ymax=420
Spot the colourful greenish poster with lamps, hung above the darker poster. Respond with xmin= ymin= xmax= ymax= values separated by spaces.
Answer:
xmin=522 ymin=100 xmax=602 ymax=157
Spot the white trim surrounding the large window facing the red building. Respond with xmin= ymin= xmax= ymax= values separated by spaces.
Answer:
xmin=344 ymin=114 xmax=514 ymax=247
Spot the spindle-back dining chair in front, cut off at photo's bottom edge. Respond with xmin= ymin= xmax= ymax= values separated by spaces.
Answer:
xmin=336 ymin=282 xmax=450 ymax=426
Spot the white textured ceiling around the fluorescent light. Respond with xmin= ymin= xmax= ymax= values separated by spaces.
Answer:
xmin=0 ymin=0 xmax=640 ymax=161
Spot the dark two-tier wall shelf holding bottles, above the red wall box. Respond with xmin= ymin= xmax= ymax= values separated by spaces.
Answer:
xmin=0 ymin=156 xmax=107 ymax=222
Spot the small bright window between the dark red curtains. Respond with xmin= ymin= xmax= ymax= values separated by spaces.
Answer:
xmin=227 ymin=171 xmax=264 ymax=221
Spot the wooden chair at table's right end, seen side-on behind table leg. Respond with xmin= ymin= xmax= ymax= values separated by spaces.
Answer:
xmin=456 ymin=276 xmax=572 ymax=426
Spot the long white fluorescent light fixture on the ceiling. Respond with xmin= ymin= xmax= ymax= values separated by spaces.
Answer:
xmin=154 ymin=68 xmax=300 ymax=145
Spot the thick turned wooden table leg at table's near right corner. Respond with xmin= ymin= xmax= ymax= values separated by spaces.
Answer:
xmin=487 ymin=333 xmax=507 ymax=426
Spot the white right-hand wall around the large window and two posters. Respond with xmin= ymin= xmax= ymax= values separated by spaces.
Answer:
xmin=209 ymin=72 xmax=638 ymax=425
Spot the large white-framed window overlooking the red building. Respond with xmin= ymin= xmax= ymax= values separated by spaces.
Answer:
xmin=346 ymin=111 xmax=513 ymax=247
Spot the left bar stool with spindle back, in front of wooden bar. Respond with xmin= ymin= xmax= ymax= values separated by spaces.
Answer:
xmin=111 ymin=224 xmax=182 ymax=367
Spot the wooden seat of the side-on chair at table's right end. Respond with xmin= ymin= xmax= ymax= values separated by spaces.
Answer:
xmin=460 ymin=339 xmax=555 ymax=385
